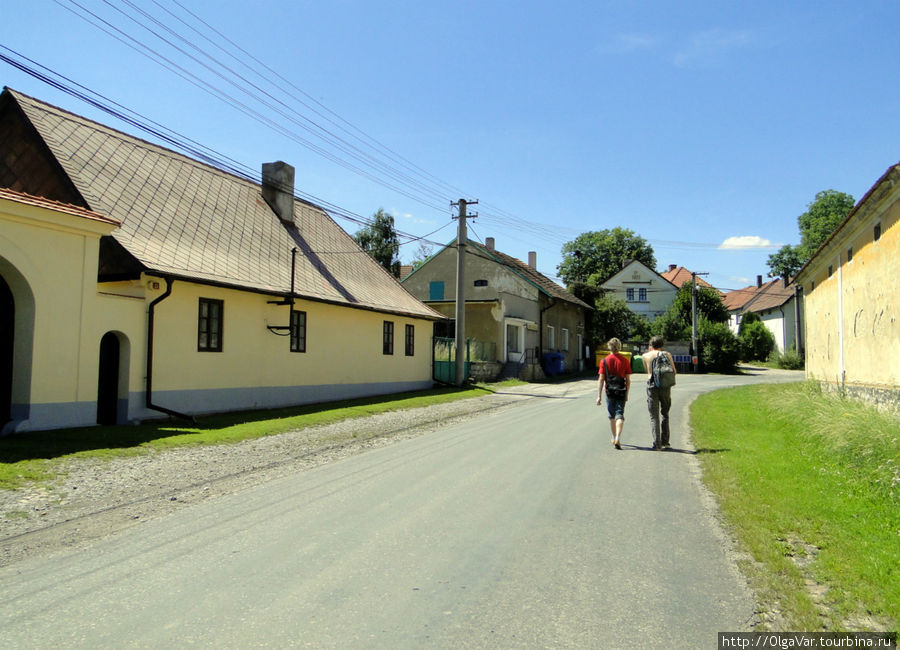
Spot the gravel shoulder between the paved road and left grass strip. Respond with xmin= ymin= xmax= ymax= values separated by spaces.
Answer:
xmin=0 ymin=379 xmax=595 ymax=566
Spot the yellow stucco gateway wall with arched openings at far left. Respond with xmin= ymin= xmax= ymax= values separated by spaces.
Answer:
xmin=0 ymin=199 xmax=143 ymax=430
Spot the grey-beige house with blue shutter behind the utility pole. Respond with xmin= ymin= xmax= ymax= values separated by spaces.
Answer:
xmin=403 ymin=237 xmax=591 ymax=374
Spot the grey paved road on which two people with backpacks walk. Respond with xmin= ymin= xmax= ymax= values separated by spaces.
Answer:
xmin=0 ymin=373 xmax=798 ymax=648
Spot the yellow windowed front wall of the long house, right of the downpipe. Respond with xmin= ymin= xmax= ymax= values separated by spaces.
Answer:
xmin=148 ymin=280 xmax=432 ymax=391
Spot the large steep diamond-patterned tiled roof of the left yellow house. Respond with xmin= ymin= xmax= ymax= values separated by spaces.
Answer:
xmin=7 ymin=90 xmax=441 ymax=318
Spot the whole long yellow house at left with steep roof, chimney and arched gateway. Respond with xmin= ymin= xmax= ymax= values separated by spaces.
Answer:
xmin=0 ymin=89 xmax=442 ymax=432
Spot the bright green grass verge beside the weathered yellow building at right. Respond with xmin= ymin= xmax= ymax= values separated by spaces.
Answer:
xmin=691 ymin=383 xmax=900 ymax=631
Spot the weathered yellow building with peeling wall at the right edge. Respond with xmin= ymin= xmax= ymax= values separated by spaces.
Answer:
xmin=794 ymin=159 xmax=900 ymax=409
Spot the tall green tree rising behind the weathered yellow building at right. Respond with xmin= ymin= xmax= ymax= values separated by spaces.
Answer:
xmin=767 ymin=190 xmax=856 ymax=278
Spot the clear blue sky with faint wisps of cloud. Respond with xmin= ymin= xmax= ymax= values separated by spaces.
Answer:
xmin=0 ymin=0 xmax=900 ymax=289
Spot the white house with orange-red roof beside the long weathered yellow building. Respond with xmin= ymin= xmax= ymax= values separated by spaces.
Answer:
xmin=722 ymin=275 xmax=801 ymax=353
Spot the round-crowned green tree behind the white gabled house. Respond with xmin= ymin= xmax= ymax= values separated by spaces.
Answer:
xmin=557 ymin=227 xmax=656 ymax=287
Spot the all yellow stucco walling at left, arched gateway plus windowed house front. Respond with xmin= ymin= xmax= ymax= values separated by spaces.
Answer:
xmin=0 ymin=198 xmax=432 ymax=432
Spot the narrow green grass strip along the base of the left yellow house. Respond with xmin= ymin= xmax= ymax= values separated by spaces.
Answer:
xmin=0 ymin=381 xmax=502 ymax=489
